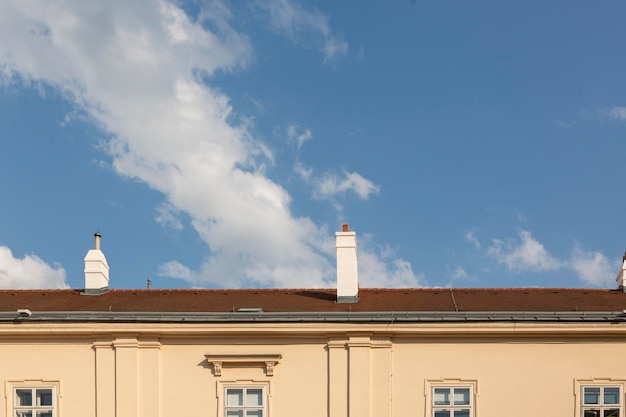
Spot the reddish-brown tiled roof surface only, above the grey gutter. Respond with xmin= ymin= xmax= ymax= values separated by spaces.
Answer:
xmin=0 ymin=288 xmax=626 ymax=313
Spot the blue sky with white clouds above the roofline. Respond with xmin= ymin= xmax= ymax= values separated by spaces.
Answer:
xmin=0 ymin=0 xmax=626 ymax=288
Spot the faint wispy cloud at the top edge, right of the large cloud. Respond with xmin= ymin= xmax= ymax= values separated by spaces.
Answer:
xmin=262 ymin=0 xmax=349 ymax=63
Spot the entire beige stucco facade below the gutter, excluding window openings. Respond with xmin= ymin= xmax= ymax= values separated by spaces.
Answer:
xmin=0 ymin=323 xmax=626 ymax=417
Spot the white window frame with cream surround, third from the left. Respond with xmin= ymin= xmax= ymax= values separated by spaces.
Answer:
xmin=424 ymin=378 xmax=478 ymax=417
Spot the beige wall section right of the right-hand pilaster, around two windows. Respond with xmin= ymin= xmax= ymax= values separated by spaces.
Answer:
xmin=393 ymin=338 xmax=626 ymax=416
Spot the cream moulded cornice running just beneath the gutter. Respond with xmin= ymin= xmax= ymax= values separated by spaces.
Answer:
xmin=0 ymin=322 xmax=626 ymax=342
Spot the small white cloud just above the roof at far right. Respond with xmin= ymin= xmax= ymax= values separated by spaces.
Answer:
xmin=571 ymin=244 xmax=618 ymax=287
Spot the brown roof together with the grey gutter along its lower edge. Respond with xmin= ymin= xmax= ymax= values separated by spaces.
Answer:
xmin=0 ymin=288 xmax=626 ymax=321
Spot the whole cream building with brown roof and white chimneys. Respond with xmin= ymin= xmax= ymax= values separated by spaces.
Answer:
xmin=0 ymin=226 xmax=626 ymax=417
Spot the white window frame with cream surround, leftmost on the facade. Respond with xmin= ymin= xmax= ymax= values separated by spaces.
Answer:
xmin=5 ymin=380 xmax=60 ymax=417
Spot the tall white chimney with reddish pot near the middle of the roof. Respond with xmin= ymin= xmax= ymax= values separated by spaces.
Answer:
xmin=335 ymin=224 xmax=359 ymax=303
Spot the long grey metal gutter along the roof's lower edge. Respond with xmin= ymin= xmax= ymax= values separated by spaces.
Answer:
xmin=0 ymin=310 xmax=626 ymax=324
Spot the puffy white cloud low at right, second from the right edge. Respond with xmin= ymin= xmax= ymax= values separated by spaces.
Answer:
xmin=487 ymin=230 xmax=562 ymax=271
